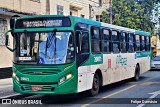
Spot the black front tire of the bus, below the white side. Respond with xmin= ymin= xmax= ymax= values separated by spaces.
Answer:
xmin=90 ymin=73 xmax=100 ymax=96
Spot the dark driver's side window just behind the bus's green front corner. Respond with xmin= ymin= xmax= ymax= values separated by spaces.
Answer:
xmin=81 ymin=32 xmax=89 ymax=53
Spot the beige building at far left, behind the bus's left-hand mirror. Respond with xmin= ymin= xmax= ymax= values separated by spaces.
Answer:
xmin=0 ymin=0 xmax=46 ymax=70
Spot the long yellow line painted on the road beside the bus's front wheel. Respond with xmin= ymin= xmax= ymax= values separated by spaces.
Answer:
xmin=81 ymin=85 xmax=136 ymax=107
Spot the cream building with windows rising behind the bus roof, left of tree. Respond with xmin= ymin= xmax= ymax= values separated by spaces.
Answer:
xmin=48 ymin=0 xmax=111 ymax=21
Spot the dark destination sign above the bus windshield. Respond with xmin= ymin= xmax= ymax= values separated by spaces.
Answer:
xmin=15 ymin=17 xmax=71 ymax=29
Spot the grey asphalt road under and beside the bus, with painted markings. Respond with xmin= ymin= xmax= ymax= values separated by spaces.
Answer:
xmin=2 ymin=71 xmax=160 ymax=107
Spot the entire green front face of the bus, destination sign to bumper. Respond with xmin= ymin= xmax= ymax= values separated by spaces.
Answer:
xmin=13 ymin=17 xmax=77 ymax=94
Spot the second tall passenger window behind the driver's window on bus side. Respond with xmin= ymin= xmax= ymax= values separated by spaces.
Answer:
xmin=102 ymin=29 xmax=111 ymax=53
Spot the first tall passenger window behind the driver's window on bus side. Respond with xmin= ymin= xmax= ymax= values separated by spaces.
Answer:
xmin=91 ymin=28 xmax=101 ymax=53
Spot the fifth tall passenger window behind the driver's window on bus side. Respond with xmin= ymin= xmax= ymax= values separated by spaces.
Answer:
xmin=128 ymin=33 xmax=134 ymax=52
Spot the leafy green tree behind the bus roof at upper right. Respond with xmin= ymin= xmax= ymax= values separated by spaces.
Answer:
xmin=102 ymin=0 xmax=156 ymax=33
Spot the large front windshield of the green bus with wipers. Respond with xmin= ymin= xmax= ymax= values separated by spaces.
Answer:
xmin=14 ymin=32 xmax=74 ymax=64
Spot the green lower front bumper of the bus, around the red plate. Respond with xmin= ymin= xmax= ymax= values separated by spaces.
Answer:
xmin=13 ymin=78 xmax=77 ymax=94
